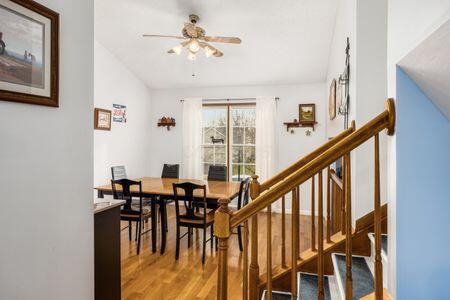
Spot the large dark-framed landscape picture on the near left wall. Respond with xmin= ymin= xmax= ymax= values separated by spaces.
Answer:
xmin=0 ymin=0 xmax=59 ymax=107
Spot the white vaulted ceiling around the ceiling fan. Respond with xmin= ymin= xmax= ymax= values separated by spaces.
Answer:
xmin=95 ymin=0 xmax=338 ymax=89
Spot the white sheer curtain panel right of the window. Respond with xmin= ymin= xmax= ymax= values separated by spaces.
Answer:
xmin=256 ymin=97 xmax=277 ymax=182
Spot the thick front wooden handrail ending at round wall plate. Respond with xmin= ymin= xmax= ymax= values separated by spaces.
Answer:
xmin=230 ymin=99 xmax=395 ymax=228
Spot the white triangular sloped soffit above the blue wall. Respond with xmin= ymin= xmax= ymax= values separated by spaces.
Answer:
xmin=399 ymin=20 xmax=450 ymax=120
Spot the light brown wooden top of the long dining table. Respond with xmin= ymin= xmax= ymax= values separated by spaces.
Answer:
xmin=95 ymin=177 xmax=240 ymax=199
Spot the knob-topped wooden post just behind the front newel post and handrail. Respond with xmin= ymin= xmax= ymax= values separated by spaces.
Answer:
xmin=249 ymin=175 xmax=261 ymax=300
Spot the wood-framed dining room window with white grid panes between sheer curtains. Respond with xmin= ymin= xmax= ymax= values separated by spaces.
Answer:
xmin=202 ymin=104 xmax=256 ymax=181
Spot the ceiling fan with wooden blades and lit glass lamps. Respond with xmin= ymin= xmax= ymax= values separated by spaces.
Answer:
xmin=143 ymin=15 xmax=241 ymax=60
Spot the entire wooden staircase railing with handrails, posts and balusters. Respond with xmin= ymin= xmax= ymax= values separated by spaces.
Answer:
xmin=214 ymin=99 xmax=395 ymax=300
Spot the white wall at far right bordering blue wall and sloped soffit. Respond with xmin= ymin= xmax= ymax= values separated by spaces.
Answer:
xmin=387 ymin=0 xmax=450 ymax=299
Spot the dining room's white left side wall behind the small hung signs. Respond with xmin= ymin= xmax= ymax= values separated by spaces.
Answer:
xmin=94 ymin=41 xmax=154 ymax=185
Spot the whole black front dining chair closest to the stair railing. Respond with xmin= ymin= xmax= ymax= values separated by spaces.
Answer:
xmin=173 ymin=182 xmax=214 ymax=264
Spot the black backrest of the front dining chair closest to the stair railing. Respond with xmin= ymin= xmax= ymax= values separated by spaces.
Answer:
xmin=173 ymin=182 xmax=207 ymax=223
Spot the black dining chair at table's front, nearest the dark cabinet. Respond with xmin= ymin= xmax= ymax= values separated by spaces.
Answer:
xmin=111 ymin=178 xmax=151 ymax=255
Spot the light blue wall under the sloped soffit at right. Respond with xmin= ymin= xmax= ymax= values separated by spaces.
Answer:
xmin=396 ymin=68 xmax=450 ymax=300
